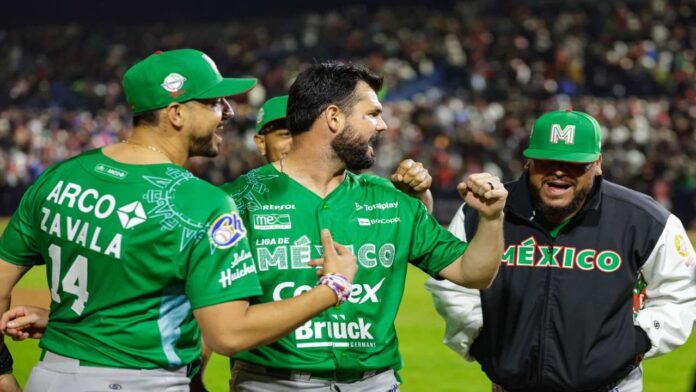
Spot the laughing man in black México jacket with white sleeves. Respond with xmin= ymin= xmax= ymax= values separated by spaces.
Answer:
xmin=426 ymin=110 xmax=696 ymax=392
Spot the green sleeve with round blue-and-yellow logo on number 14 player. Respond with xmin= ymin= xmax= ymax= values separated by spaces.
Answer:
xmin=186 ymin=198 xmax=262 ymax=309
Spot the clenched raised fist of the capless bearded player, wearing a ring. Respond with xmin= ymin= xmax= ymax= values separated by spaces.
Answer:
xmin=457 ymin=173 xmax=507 ymax=220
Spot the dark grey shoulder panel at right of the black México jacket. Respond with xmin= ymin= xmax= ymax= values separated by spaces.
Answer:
xmin=602 ymin=180 xmax=670 ymax=225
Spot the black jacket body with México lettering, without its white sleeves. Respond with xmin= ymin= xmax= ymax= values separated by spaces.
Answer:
xmin=464 ymin=175 xmax=670 ymax=391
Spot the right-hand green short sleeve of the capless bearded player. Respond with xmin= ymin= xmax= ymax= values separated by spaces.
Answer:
xmin=409 ymin=203 xmax=467 ymax=279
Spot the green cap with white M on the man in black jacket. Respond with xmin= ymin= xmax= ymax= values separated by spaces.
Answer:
xmin=523 ymin=110 xmax=602 ymax=163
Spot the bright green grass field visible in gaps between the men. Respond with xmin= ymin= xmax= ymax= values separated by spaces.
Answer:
xmin=0 ymin=217 xmax=696 ymax=392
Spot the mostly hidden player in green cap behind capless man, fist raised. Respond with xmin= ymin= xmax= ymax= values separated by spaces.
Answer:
xmin=254 ymin=95 xmax=433 ymax=212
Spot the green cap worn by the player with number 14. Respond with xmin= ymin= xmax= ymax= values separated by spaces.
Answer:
xmin=123 ymin=49 xmax=256 ymax=113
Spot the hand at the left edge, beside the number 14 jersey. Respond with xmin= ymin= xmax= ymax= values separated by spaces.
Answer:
xmin=0 ymin=306 xmax=49 ymax=340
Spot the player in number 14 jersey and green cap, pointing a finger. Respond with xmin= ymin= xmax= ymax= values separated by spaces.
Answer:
xmin=0 ymin=49 xmax=357 ymax=392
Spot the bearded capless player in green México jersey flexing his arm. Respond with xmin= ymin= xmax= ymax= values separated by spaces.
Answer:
xmin=223 ymin=63 xmax=507 ymax=392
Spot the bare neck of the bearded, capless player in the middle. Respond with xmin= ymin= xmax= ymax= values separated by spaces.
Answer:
xmin=273 ymin=135 xmax=346 ymax=197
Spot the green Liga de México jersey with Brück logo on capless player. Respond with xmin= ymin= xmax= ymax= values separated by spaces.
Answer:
xmin=223 ymin=164 xmax=466 ymax=371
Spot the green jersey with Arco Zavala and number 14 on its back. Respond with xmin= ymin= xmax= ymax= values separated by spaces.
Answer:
xmin=0 ymin=149 xmax=261 ymax=368
